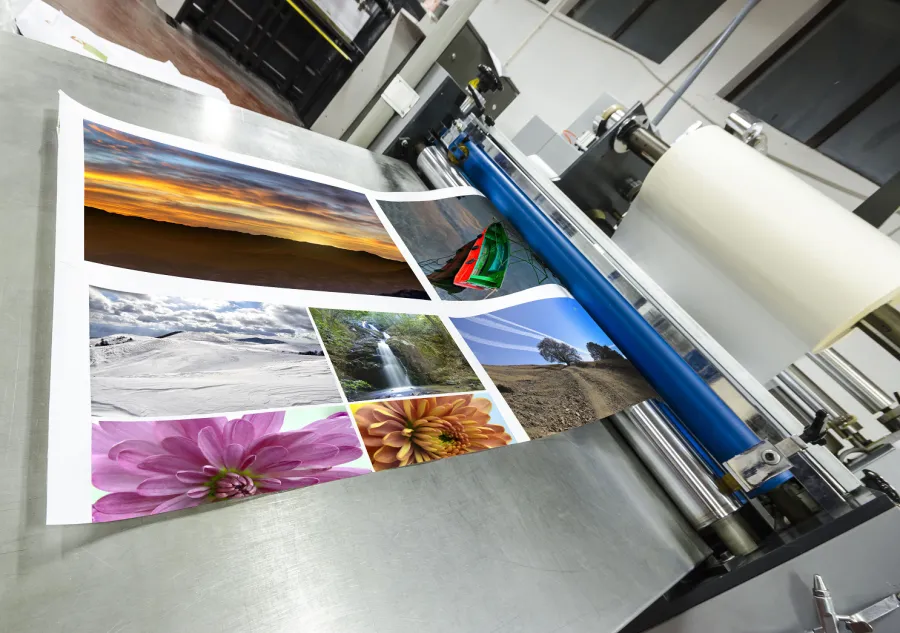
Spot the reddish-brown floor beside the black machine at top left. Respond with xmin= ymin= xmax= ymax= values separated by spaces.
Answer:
xmin=45 ymin=0 xmax=303 ymax=127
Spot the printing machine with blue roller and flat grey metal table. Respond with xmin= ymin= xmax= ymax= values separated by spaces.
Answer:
xmin=0 ymin=16 xmax=900 ymax=633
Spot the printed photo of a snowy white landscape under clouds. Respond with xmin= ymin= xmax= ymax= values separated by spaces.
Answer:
xmin=88 ymin=287 xmax=341 ymax=417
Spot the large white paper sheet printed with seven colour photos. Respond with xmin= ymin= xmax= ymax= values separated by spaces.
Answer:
xmin=47 ymin=95 xmax=653 ymax=523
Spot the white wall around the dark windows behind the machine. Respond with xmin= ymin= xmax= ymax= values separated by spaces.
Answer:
xmin=471 ymin=0 xmax=900 ymax=437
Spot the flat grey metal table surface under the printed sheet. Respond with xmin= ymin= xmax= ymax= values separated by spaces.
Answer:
xmin=0 ymin=35 xmax=702 ymax=633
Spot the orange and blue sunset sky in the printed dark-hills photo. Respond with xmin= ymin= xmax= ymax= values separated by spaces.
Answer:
xmin=84 ymin=121 xmax=403 ymax=261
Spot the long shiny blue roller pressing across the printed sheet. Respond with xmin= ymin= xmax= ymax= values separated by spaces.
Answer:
xmin=451 ymin=140 xmax=790 ymax=492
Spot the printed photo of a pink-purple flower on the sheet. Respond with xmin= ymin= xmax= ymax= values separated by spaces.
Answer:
xmin=91 ymin=405 xmax=371 ymax=523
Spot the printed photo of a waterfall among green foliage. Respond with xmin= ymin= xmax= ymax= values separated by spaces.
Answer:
xmin=310 ymin=308 xmax=483 ymax=402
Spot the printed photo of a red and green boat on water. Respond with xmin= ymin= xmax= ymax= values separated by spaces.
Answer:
xmin=378 ymin=196 xmax=559 ymax=301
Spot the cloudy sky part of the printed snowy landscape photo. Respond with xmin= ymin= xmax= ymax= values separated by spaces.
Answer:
xmin=89 ymin=286 xmax=318 ymax=344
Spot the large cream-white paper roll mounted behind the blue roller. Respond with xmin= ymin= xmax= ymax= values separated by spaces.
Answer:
xmin=636 ymin=126 xmax=900 ymax=351
